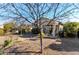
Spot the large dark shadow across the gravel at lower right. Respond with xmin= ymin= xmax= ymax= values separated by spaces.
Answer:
xmin=45 ymin=39 xmax=79 ymax=52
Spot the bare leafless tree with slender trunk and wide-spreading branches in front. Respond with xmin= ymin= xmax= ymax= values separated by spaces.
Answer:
xmin=0 ymin=3 xmax=76 ymax=52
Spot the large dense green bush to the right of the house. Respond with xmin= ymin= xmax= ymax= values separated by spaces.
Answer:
xmin=64 ymin=22 xmax=79 ymax=37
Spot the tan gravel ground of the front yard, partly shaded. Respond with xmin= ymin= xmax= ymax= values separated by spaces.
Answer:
xmin=0 ymin=35 xmax=79 ymax=55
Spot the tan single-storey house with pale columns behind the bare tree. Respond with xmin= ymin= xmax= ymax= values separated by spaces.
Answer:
xmin=34 ymin=17 xmax=63 ymax=37
